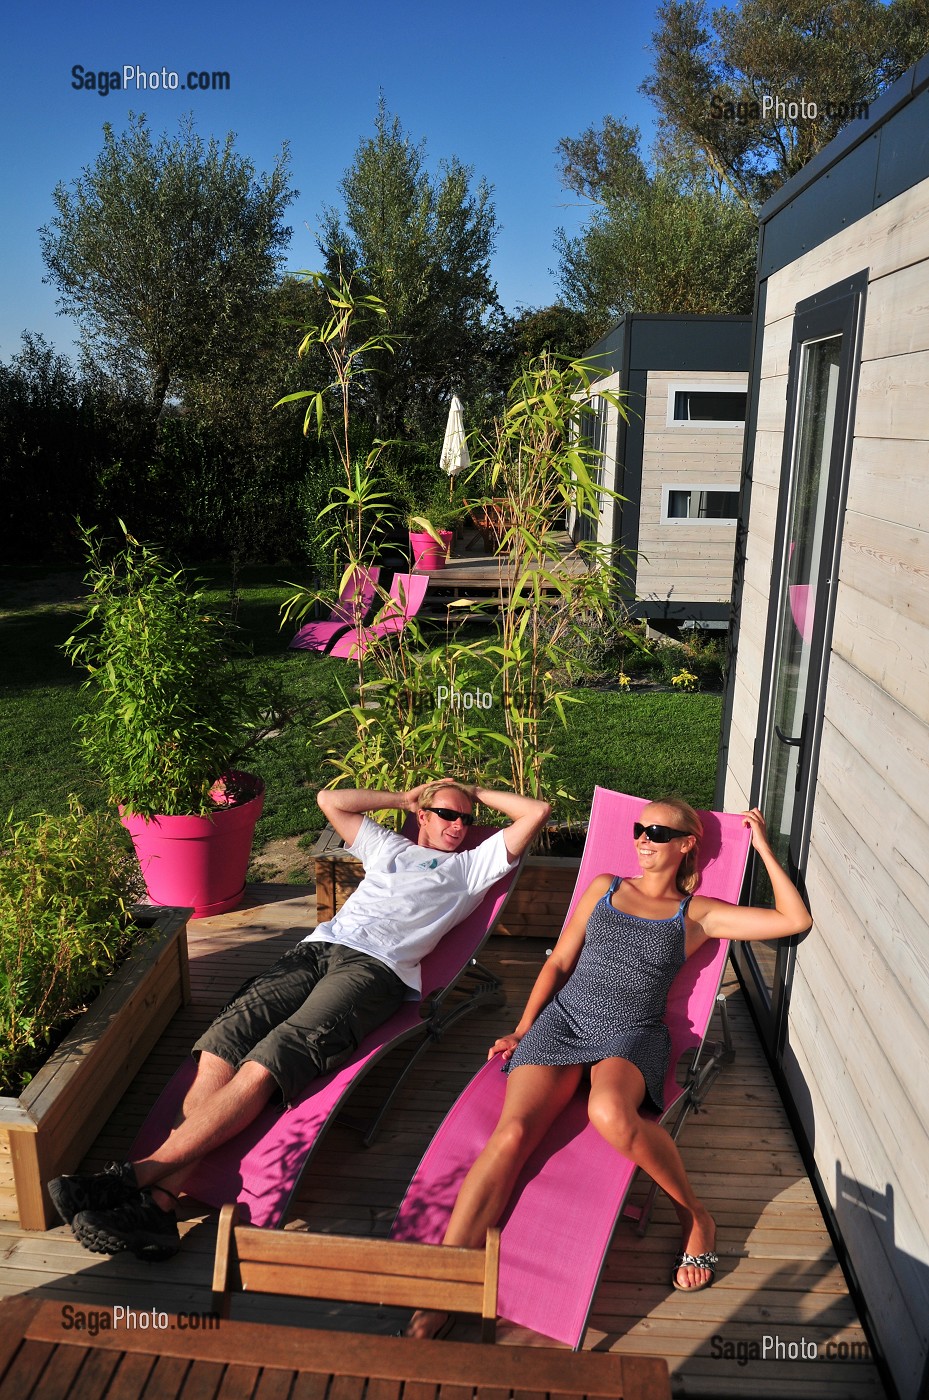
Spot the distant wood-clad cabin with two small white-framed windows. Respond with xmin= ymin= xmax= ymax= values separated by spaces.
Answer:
xmin=582 ymin=314 xmax=751 ymax=626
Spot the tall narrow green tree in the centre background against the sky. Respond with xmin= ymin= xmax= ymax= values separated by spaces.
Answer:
xmin=320 ymin=98 xmax=499 ymax=437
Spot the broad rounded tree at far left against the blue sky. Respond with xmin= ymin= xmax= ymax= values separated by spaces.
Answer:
xmin=39 ymin=113 xmax=295 ymax=412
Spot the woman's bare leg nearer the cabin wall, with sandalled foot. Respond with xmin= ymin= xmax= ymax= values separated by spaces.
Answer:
xmin=588 ymin=1058 xmax=716 ymax=1288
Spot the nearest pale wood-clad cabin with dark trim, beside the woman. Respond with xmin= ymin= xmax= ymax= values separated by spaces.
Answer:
xmin=718 ymin=57 xmax=929 ymax=1400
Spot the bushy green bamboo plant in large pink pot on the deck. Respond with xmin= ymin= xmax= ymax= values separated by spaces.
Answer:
xmin=64 ymin=522 xmax=280 ymax=918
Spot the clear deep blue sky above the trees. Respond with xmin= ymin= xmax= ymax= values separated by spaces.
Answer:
xmin=0 ymin=0 xmax=653 ymax=361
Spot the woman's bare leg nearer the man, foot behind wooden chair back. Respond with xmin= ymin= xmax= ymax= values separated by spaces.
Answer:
xmin=406 ymin=1064 xmax=581 ymax=1337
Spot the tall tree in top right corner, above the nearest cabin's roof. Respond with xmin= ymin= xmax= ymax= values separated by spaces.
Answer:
xmin=642 ymin=0 xmax=929 ymax=211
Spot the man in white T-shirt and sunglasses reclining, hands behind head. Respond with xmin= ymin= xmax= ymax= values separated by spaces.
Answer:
xmin=49 ymin=781 xmax=550 ymax=1260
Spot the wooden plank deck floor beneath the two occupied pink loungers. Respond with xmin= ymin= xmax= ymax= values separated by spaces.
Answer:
xmin=0 ymin=885 xmax=884 ymax=1400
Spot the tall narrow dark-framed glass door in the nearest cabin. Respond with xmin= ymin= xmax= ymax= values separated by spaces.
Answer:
xmin=735 ymin=274 xmax=866 ymax=1053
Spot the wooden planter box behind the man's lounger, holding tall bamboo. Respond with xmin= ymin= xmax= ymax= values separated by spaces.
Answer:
xmin=313 ymin=826 xmax=581 ymax=941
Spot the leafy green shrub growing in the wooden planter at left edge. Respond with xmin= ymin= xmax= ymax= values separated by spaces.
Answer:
xmin=0 ymin=798 xmax=140 ymax=1093
